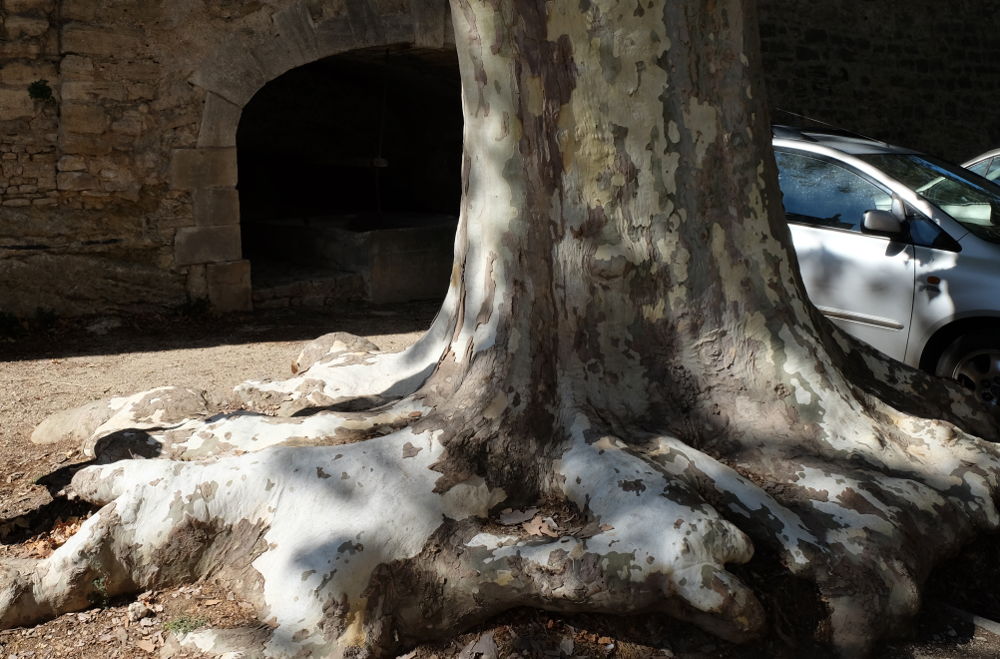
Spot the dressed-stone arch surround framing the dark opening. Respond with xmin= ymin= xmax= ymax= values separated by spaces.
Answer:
xmin=170 ymin=0 xmax=454 ymax=311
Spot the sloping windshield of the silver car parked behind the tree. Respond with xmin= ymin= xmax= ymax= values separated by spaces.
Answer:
xmin=858 ymin=153 xmax=1000 ymax=243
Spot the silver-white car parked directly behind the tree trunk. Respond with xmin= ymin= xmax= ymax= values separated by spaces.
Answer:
xmin=773 ymin=126 xmax=1000 ymax=404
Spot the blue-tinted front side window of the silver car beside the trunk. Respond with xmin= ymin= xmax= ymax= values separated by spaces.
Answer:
xmin=774 ymin=151 xmax=892 ymax=232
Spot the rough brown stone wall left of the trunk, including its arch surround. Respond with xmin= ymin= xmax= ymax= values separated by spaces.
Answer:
xmin=0 ymin=0 xmax=453 ymax=316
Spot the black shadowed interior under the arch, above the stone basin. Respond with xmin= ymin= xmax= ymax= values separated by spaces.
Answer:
xmin=236 ymin=48 xmax=462 ymax=226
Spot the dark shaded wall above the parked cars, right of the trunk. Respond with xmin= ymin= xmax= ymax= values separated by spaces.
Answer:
xmin=758 ymin=0 xmax=1000 ymax=161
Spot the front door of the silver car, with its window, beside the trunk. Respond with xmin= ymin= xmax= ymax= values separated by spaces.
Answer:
xmin=775 ymin=150 xmax=915 ymax=360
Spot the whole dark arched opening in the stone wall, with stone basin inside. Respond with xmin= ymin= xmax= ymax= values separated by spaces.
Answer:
xmin=236 ymin=47 xmax=462 ymax=307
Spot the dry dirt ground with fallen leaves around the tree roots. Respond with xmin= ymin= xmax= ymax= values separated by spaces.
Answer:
xmin=0 ymin=303 xmax=1000 ymax=659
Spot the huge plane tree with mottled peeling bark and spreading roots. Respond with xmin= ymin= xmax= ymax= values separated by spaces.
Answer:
xmin=0 ymin=0 xmax=1000 ymax=656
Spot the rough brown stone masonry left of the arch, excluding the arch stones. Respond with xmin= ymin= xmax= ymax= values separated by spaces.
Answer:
xmin=0 ymin=0 xmax=209 ymax=316
